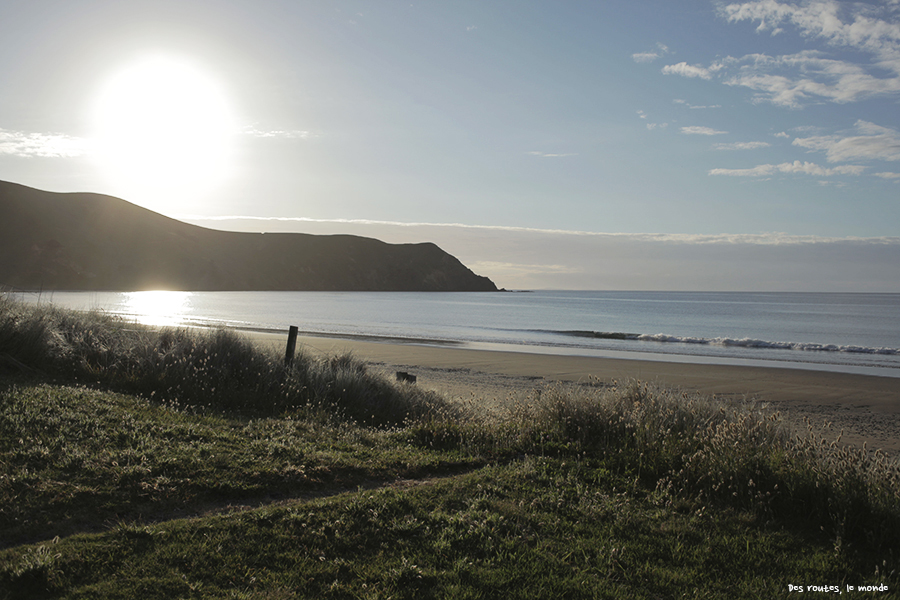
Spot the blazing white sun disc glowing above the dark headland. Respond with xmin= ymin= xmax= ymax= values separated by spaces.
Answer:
xmin=93 ymin=56 xmax=235 ymax=210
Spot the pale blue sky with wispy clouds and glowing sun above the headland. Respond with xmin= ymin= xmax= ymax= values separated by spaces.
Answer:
xmin=0 ymin=0 xmax=900 ymax=291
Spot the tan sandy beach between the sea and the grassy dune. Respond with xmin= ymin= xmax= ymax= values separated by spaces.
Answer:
xmin=249 ymin=332 xmax=900 ymax=457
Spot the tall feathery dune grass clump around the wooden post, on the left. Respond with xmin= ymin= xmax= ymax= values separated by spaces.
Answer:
xmin=0 ymin=298 xmax=453 ymax=427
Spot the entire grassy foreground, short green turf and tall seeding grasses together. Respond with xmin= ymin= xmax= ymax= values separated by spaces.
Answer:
xmin=0 ymin=299 xmax=900 ymax=599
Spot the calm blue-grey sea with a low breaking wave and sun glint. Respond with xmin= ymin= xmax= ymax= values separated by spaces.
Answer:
xmin=12 ymin=291 xmax=900 ymax=377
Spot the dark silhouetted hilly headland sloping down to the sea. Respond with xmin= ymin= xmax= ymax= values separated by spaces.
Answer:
xmin=0 ymin=182 xmax=497 ymax=291
